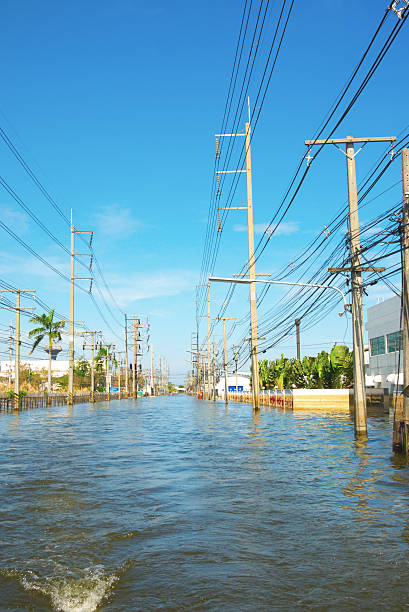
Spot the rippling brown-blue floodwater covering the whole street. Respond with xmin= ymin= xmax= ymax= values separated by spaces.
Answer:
xmin=0 ymin=396 xmax=409 ymax=612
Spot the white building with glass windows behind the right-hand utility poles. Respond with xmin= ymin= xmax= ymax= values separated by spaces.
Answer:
xmin=366 ymin=296 xmax=403 ymax=392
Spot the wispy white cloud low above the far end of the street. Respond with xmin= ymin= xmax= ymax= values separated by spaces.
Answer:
xmin=108 ymin=269 xmax=198 ymax=306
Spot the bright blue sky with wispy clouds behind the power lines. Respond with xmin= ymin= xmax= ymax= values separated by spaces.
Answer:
xmin=0 ymin=0 xmax=409 ymax=382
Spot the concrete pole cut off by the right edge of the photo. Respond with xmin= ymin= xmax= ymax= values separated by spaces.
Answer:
xmin=393 ymin=149 xmax=409 ymax=454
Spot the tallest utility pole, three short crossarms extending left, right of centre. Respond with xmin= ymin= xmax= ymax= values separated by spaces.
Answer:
xmin=216 ymin=102 xmax=260 ymax=412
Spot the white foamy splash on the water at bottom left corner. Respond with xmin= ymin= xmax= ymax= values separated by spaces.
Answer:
xmin=19 ymin=566 xmax=119 ymax=612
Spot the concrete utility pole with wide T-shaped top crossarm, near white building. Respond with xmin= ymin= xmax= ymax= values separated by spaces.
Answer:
xmin=305 ymin=136 xmax=396 ymax=436
